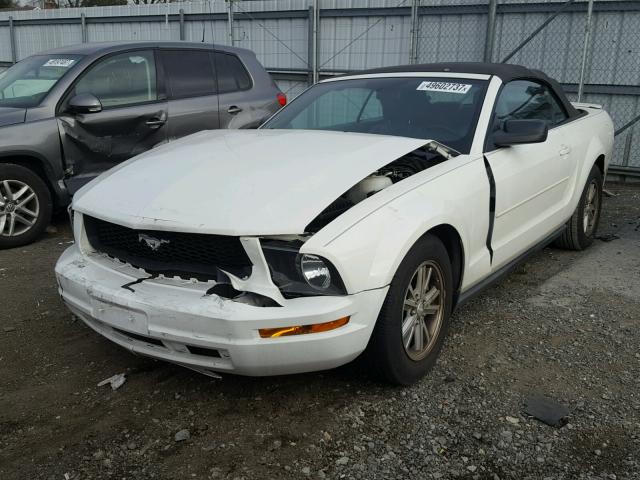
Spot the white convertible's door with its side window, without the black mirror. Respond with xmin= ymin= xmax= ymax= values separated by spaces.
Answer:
xmin=485 ymin=80 xmax=575 ymax=268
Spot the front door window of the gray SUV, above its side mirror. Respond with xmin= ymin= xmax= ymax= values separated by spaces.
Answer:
xmin=74 ymin=50 xmax=158 ymax=108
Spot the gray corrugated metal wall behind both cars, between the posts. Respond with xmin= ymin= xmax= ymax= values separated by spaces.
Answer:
xmin=0 ymin=0 xmax=640 ymax=167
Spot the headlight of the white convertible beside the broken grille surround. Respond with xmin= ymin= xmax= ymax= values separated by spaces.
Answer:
xmin=261 ymin=240 xmax=347 ymax=298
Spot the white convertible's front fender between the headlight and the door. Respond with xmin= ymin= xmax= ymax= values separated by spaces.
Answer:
xmin=301 ymin=157 xmax=489 ymax=293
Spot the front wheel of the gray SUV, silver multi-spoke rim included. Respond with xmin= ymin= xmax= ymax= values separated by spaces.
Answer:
xmin=0 ymin=163 xmax=52 ymax=249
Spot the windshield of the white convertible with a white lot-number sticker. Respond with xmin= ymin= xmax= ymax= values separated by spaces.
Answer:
xmin=262 ymin=77 xmax=486 ymax=153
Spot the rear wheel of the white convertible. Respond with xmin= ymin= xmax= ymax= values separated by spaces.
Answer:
xmin=554 ymin=165 xmax=603 ymax=250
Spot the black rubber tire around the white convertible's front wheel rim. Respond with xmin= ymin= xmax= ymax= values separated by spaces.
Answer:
xmin=372 ymin=234 xmax=453 ymax=385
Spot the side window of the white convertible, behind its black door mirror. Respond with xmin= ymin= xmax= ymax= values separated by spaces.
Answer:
xmin=494 ymin=80 xmax=568 ymax=129
